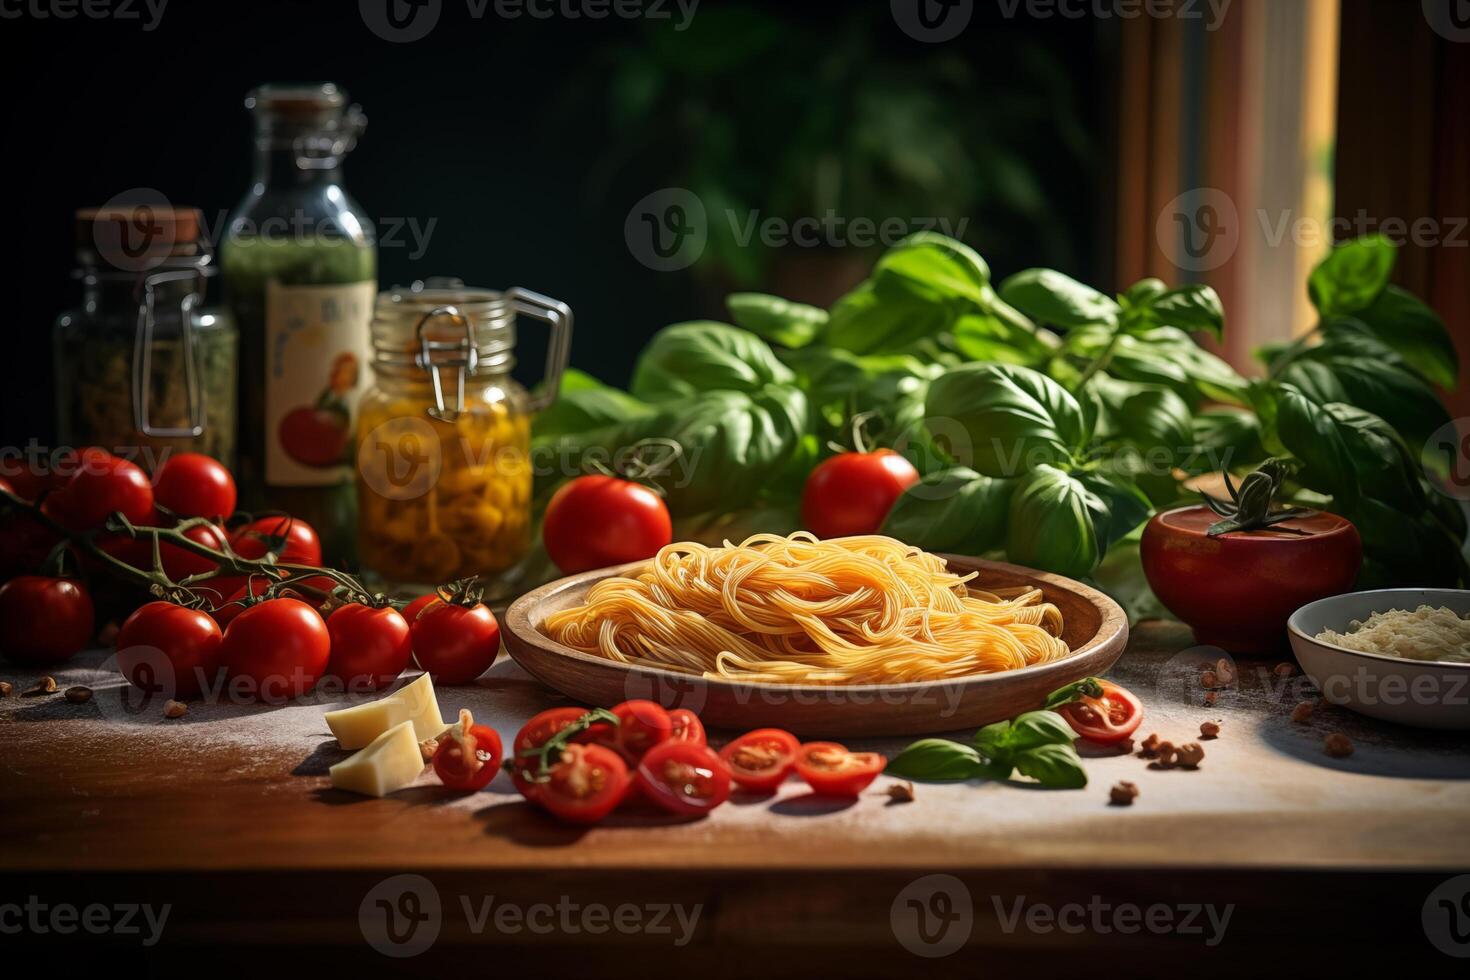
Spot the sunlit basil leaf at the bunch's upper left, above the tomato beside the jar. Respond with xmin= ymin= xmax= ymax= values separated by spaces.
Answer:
xmin=632 ymin=320 xmax=795 ymax=401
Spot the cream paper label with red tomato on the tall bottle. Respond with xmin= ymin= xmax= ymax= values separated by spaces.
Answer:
xmin=265 ymin=279 xmax=378 ymax=486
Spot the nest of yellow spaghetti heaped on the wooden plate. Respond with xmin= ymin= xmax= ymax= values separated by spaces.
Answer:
xmin=544 ymin=532 xmax=1069 ymax=683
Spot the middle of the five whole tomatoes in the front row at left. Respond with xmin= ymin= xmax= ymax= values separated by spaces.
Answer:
xmin=219 ymin=598 xmax=332 ymax=701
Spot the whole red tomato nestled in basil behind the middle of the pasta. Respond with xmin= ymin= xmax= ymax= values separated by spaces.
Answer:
xmin=801 ymin=450 xmax=919 ymax=538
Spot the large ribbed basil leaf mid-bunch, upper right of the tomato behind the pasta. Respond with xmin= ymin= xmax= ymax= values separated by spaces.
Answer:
xmin=925 ymin=364 xmax=1086 ymax=478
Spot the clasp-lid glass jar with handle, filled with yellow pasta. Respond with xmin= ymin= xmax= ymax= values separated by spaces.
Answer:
xmin=357 ymin=279 xmax=572 ymax=591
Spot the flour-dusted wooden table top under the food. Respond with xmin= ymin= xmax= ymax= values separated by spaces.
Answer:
xmin=0 ymin=623 xmax=1470 ymax=973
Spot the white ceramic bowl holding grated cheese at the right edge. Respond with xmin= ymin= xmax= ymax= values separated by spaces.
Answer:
xmin=1286 ymin=589 xmax=1470 ymax=730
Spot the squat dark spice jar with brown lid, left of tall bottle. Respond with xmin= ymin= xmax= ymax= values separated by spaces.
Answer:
xmin=53 ymin=203 xmax=238 ymax=469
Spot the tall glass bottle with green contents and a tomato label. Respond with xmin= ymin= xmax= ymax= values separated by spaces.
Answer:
xmin=221 ymin=84 xmax=378 ymax=563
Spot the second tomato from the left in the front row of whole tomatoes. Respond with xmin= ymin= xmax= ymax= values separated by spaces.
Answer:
xmin=118 ymin=602 xmax=221 ymax=698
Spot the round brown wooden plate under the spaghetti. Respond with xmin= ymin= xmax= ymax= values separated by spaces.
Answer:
xmin=506 ymin=555 xmax=1127 ymax=738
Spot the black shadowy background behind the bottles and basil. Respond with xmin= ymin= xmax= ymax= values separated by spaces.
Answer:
xmin=0 ymin=0 xmax=1116 ymax=445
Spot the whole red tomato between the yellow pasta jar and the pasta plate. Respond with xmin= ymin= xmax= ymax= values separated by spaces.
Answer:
xmin=541 ymin=476 xmax=673 ymax=574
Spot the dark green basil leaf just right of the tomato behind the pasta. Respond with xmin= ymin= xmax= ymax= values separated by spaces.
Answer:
xmin=882 ymin=466 xmax=1011 ymax=555
